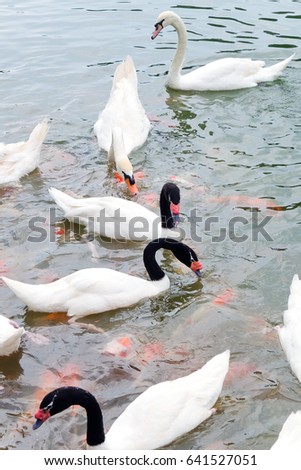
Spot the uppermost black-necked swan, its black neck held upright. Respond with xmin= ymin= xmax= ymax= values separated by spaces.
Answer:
xmin=49 ymin=183 xmax=180 ymax=241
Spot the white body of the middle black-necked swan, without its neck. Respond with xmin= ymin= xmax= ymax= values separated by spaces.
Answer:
xmin=2 ymin=268 xmax=170 ymax=319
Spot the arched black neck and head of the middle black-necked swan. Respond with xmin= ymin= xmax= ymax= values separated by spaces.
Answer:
xmin=143 ymin=238 xmax=198 ymax=281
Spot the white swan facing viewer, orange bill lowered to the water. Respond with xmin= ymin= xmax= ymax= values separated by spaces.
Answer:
xmin=94 ymin=56 xmax=151 ymax=193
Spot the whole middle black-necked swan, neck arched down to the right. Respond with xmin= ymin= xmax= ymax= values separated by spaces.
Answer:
xmin=2 ymin=238 xmax=202 ymax=321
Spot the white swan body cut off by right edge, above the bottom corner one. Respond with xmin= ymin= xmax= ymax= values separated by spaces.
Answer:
xmin=277 ymin=274 xmax=301 ymax=382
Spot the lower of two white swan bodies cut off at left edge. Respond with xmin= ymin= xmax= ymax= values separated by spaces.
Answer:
xmin=0 ymin=315 xmax=25 ymax=356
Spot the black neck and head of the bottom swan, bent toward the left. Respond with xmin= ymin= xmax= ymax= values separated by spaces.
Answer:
xmin=40 ymin=387 xmax=105 ymax=446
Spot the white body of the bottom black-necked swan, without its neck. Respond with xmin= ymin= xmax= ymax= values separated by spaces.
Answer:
xmin=99 ymin=350 xmax=230 ymax=450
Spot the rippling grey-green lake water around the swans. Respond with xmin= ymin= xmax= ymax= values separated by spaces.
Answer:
xmin=0 ymin=0 xmax=301 ymax=449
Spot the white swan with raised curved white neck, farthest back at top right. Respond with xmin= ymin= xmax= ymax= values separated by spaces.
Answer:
xmin=151 ymin=11 xmax=295 ymax=91
